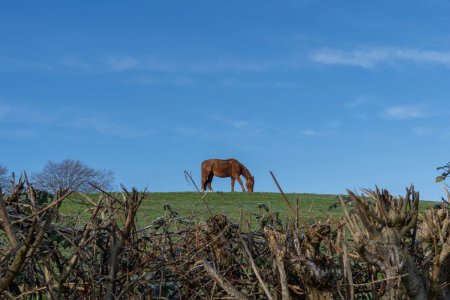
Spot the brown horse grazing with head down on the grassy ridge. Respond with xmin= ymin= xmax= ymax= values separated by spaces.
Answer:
xmin=202 ymin=158 xmax=255 ymax=192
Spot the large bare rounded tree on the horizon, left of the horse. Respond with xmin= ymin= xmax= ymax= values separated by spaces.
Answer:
xmin=33 ymin=159 xmax=114 ymax=194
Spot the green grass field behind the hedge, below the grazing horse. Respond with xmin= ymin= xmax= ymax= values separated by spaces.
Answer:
xmin=60 ymin=192 xmax=436 ymax=226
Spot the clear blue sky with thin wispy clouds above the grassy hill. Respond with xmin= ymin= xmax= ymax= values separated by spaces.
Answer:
xmin=0 ymin=0 xmax=450 ymax=200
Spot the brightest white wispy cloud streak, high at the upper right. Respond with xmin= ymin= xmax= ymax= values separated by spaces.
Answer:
xmin=310 ymin=47 xmax=450 ymax=69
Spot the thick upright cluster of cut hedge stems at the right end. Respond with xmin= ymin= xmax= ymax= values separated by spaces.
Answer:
xmin=342 ymin=187 xmax=450 ymax=299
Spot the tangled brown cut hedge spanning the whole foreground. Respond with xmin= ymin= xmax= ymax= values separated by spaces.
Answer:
xmin=0 ymin=172 xmax=450 ymax=299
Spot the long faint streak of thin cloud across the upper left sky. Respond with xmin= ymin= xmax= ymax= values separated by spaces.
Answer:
xmin=0 ymin=54 xmax=281 ymax=73
